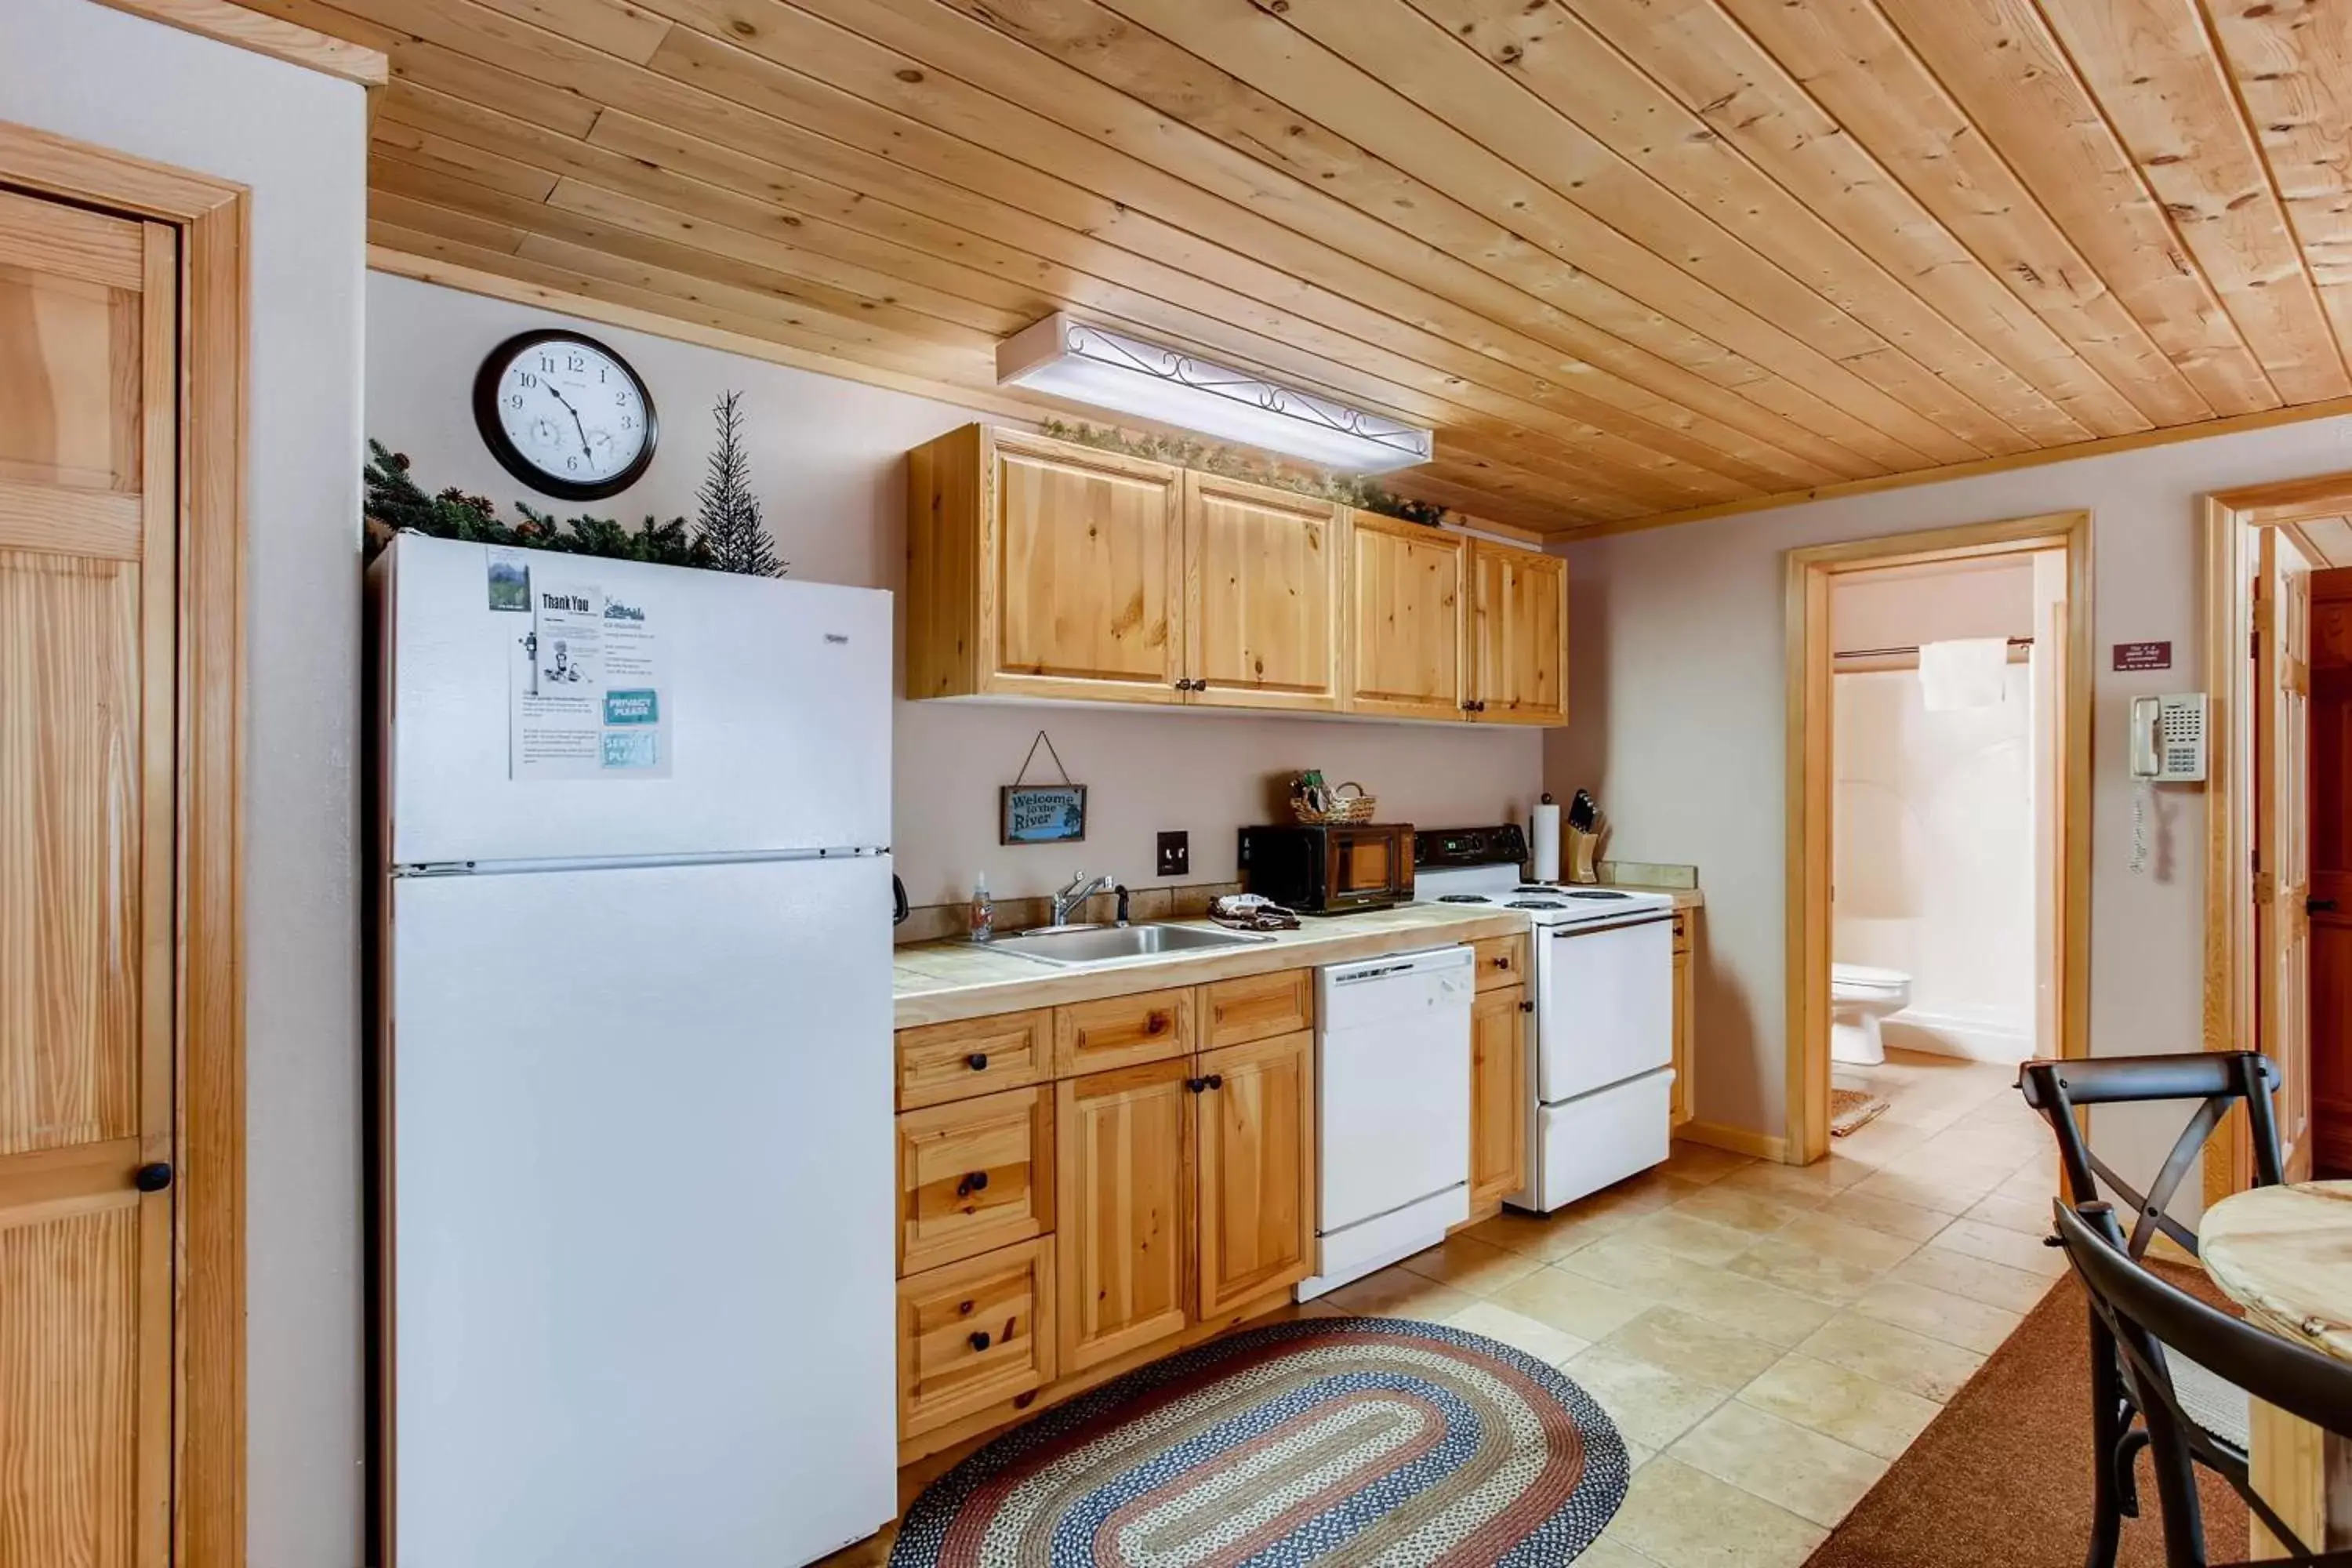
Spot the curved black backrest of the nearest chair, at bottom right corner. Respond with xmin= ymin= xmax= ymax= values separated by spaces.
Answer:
xmin=2051 ymin=1201 xmax=2352 ymax=1556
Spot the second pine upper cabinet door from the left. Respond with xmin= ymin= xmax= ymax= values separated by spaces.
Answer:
xmin=1183 ymin=470 xmax=1345 ymax=713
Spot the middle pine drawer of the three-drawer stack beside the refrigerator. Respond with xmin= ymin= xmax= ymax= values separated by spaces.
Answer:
xmin=898 ymin=1088 xmax=1054 ymax=1274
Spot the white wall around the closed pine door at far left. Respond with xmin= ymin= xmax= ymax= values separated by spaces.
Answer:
xmin=0 ymin=0 xmax=367 ymax=1568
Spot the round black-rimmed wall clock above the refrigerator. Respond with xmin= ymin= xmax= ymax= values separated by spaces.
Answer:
xmin=473 ymin=332 xmax=661 ymax=501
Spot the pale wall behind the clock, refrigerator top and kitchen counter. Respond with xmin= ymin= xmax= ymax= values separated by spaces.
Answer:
xmin=367 ymin=273 xmax=1543 ymax=902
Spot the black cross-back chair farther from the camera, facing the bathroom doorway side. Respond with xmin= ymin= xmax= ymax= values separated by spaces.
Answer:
xmin=2018 ymin=1051 xmax=2284 ymax=1568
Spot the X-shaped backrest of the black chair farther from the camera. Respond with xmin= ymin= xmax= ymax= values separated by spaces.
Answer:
xmin=2018 ymin=1051 xmax=2286 ymax=1258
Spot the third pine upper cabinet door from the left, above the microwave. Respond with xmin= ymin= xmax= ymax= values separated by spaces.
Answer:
xmin=1345 ymin=513 xmax=1468 ymax=720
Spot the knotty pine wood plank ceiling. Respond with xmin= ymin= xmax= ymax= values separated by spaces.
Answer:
xmin=267 ymin=0 xmax=2352 ymax=532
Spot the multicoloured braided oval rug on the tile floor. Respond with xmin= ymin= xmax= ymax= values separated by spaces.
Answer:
xmin=889 ymin=1316 xmax=1625 ymax=1568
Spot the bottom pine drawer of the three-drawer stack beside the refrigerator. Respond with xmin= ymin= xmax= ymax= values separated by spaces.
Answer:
xmin=894 ymin=1241 xmax=1054 ymax=1441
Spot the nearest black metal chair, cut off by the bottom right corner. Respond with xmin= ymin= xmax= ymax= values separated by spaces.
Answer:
xmin=2051 ymin=1201 xmax=2352 ymax=1568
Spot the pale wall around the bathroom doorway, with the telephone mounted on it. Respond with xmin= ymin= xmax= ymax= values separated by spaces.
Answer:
xmin=1545 ymin=419 xmax=2352 ymax=1187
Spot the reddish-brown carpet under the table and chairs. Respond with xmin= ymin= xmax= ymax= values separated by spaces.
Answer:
xmin=1806 ymin=1262 xmax=2246 ymax=1568
